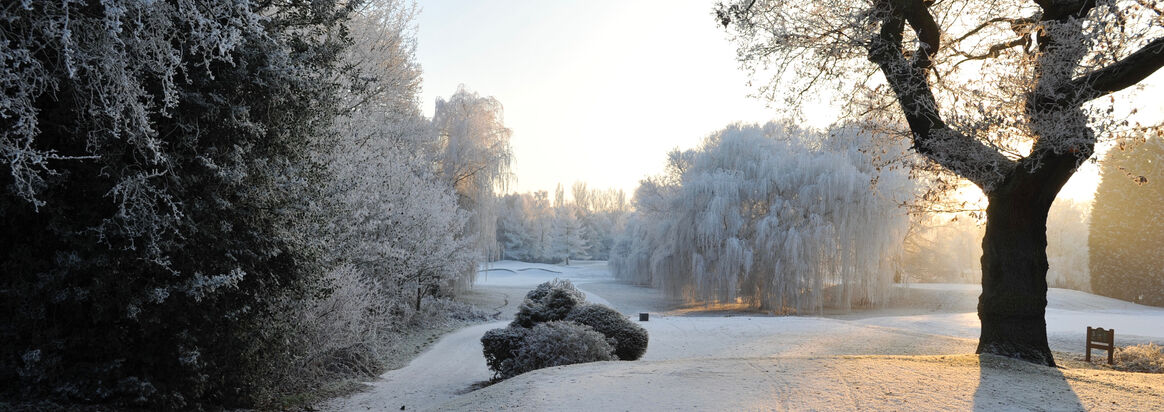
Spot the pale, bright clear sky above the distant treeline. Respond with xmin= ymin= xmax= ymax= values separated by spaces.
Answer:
xmin=417 ymin=0 xmax=1164 ymax=200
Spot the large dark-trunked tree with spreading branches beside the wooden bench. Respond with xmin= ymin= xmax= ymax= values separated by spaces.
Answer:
xmin=716 ymin=0 xmax=1164 ymax=364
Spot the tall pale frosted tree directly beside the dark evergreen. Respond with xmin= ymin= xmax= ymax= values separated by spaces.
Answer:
xmin=327 ymin=1 xmax=480 ymax=310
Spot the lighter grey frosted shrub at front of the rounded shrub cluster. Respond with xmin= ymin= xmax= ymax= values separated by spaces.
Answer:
xmin=501 ymin=321 xmax=617 ymax=378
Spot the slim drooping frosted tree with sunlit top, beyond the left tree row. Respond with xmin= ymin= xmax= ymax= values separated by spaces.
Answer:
xmin=432 ymin=85 xmax=513 ymax=264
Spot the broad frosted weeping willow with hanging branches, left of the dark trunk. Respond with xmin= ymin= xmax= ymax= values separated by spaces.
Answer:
xmin=611 ymin=123 xmax=913 ymax=313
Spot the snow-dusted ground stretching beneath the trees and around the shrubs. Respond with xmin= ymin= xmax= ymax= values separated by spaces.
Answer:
xmin=321 ymin=262 xmax=1164 ymax=411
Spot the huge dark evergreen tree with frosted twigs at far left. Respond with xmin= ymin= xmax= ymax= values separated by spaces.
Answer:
xmin=0 ymin=0 xmax=354 ymax=409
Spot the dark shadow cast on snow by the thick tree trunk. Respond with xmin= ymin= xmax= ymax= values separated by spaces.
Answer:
xmin=974 ymin=355 xmax=1085 ymax=411
